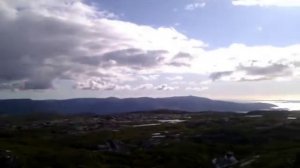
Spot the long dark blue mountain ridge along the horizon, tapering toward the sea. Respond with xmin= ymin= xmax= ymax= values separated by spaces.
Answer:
xmin=0 ymin=96 xmax=276 ymax=114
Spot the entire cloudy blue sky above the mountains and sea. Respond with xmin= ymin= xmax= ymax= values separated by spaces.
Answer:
xmin=0 ymin=0 xmax=300 ymax=100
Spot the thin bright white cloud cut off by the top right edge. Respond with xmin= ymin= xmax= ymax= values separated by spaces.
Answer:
xmin=232 ymin=0 xmax=300 ymax=7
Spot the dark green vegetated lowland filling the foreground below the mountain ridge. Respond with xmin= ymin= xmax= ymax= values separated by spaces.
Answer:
xmin=0 ymin=111 xmax=300 ymax=168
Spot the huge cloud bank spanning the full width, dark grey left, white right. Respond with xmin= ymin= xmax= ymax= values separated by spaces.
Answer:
xmin=0 ymin=0 xmax=300 ymax=93
